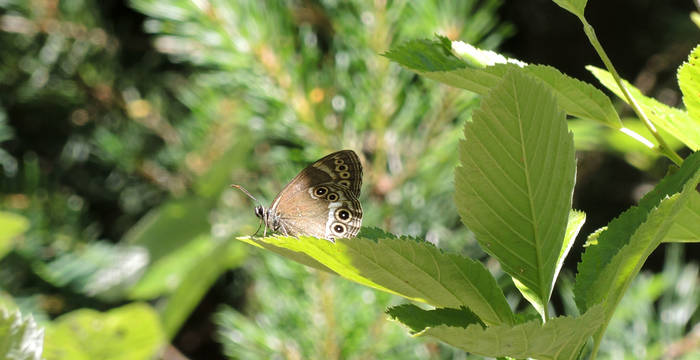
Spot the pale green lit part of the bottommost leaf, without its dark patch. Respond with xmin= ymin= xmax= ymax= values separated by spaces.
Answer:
xmin=419 ymin=306 xmax=604 ymax=360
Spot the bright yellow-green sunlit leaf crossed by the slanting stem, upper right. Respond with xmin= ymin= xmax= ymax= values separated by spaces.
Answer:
xmin=586 ymin=65 xmax=700 ymax=151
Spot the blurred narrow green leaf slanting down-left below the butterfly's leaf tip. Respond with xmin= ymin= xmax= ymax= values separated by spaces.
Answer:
xmin=160 ymin=237 xmax=247 ymax=339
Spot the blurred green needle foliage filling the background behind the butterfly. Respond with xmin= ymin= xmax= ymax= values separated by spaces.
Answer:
xmin=0 ymin=0 xmax=692 ymax=359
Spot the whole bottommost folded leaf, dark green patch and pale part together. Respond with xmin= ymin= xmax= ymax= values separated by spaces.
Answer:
xmin=390 ymin=306 xmax=604 ymax=360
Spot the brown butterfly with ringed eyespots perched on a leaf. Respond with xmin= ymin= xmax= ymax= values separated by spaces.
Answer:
xmin=255 ymin=150 xmax=362 ymax=241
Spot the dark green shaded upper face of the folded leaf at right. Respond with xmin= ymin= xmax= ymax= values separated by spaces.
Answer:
xmin=574 ymin=152 xmax=700 ymax=311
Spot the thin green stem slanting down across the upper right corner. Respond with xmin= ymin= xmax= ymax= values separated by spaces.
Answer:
xmin=579 ymin=16 xmax=683 ymax=166
